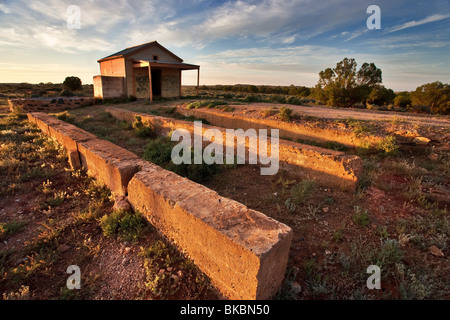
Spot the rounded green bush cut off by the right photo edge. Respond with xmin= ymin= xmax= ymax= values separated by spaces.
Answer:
xmin=411 ymin=81 xmax=450 ymax=114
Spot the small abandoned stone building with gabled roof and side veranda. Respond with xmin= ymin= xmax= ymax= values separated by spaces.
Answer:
xmin=94 ymin=41 xmax=200 ymax=101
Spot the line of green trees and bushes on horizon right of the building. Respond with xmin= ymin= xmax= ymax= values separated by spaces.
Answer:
xmin=202 ymin=58 xmax=450 ymax=114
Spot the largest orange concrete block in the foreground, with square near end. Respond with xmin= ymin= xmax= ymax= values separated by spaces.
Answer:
xmin=128 ymin=163 xmax=292 ymax=299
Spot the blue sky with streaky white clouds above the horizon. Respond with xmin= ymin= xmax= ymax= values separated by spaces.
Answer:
xmin=0 ymin=0 xmax=450 ymax=91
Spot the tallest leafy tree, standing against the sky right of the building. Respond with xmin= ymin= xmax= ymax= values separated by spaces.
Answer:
xmin=314 ymin=58 xmax=382 ymax=107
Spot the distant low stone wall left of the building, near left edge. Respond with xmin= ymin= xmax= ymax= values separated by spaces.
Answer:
xmin=8 ymin=97 xmax=94 ymax=112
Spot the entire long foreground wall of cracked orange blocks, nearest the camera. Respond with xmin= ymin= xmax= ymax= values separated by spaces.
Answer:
xmin=28 ymin=113 xmax=292 ymax=299
